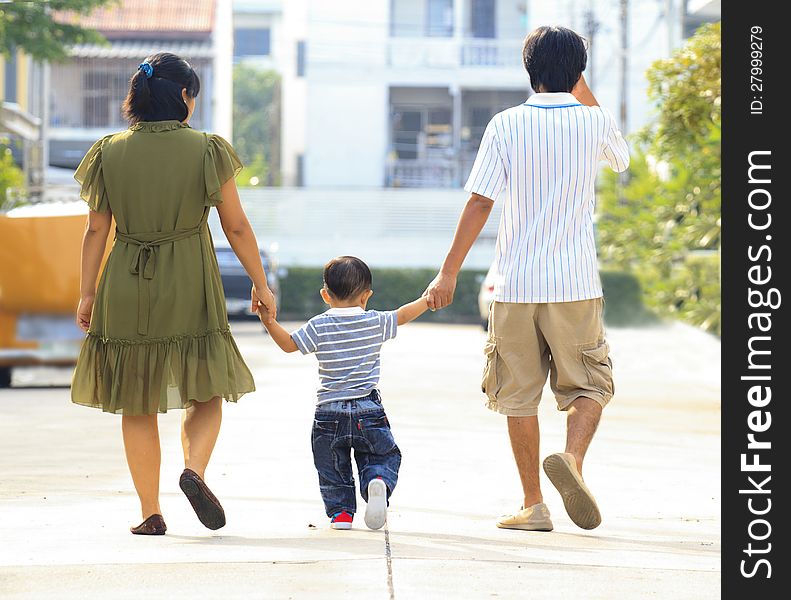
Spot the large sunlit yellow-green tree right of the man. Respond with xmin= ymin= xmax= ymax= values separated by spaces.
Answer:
xmin=598 ymin=23 xmax=722 ymax=333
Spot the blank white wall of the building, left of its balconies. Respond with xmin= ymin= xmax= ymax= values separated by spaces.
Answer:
xmin=284 ymin=0 xmax=390 ymax=187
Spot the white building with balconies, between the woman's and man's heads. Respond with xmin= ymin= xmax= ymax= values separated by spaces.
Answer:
xmin=281 ymin=0 xmax=528 ymax=187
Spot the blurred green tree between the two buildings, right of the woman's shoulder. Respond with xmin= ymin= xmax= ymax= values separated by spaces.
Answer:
xmin=233 ymin=64 xmax=280 ymax=185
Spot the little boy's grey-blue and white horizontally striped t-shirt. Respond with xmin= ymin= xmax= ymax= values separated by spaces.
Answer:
xmin=291 ymin=306 xmax=398 ymax=405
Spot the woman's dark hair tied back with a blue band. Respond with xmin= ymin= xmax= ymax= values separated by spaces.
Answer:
xmin=121 ymin=52 xmax=200 ymax=125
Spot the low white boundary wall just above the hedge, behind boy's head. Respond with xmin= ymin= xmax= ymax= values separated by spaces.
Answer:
xmin=209 ymin=188 xmax=502 ymax=270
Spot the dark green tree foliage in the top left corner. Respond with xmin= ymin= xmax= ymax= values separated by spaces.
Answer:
xmin=0 ymin=0 xmax=117 ymax=61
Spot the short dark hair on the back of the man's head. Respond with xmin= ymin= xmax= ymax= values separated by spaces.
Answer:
xmin=522 ymin=27 xmax=588 ymax=92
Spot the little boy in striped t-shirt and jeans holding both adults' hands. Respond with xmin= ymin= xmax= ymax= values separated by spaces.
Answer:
xmin=259 ymin=256 xmax=428 ymax=529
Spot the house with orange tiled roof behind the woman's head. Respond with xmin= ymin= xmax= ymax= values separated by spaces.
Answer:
xmin=46 ymin=0 xmax=233 ymax=168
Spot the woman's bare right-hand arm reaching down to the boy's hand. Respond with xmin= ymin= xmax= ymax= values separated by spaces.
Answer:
xmin=217 ymin=178 xmax=277 ymax=318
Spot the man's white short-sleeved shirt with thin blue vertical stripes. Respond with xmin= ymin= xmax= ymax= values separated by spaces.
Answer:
xmin=464 ymin=93 xmax=629 ymax=302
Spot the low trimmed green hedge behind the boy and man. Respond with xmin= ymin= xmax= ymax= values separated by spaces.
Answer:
xmin=280 ymin=267 xmax=656 ymax=326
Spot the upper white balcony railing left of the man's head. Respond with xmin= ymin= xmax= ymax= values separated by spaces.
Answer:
xmin=387 ymin=37 xmax=522 ymax=69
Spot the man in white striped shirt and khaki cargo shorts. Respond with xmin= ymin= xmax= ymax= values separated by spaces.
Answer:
xmin=426 ymin=27 xmax=629 ymax=531
